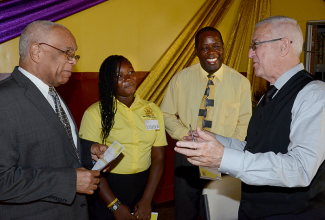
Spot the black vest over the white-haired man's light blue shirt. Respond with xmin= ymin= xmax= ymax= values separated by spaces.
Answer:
xmin=240 ymin=70 xmax=325 ymax=219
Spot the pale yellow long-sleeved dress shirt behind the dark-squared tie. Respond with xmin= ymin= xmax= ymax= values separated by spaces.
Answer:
xmin=160 ymin=63 xmax=252 ymax=141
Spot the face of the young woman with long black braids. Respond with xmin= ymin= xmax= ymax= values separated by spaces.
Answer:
xmin=116 ymin=59 xmax=137 ymax=100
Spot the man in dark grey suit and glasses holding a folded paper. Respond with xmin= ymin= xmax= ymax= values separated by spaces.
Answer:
xmin=0 ymin=21 xmax=107 ymax=220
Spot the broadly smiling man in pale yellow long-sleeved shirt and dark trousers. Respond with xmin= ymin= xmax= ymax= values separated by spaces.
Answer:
xmin=160 ymin=27 xmax=252 ymax=220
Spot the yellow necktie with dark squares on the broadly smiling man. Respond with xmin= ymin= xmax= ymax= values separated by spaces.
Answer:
xmin=197 ymin=75 xmax=214 ymax=131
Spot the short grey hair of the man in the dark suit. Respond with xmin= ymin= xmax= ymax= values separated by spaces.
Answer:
xmin=19 ymin=20 xmax=66 ymax=60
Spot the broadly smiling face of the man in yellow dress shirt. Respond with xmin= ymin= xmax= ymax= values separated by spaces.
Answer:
xmin=195 ymin=31 xmax=224 ymax=74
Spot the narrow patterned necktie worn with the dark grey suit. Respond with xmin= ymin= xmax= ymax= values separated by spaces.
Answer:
xmin=49 ymin=87 xmax=81 ymax=162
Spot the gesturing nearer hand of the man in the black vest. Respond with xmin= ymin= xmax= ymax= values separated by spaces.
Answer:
xmin=175 ymin=127 xmax=224 ymax=167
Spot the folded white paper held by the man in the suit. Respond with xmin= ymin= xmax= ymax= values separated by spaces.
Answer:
xmin=92 ymin=141 xmax=125 ymax=171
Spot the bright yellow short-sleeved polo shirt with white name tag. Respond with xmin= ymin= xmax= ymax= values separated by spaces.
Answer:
xmin=79 ymin=94 xmax=167 ymax=174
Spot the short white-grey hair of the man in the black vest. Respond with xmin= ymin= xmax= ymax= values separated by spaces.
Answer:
xmin=255 ymin=16 xmax=304 ymax=57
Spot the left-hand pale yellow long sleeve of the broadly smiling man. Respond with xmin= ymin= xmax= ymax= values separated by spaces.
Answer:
xmin=160 ymin=75 xmax=189 ymax=140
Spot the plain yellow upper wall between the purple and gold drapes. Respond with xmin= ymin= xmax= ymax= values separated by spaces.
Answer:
xmin=0 ymin=0 xmax=240 ymax=73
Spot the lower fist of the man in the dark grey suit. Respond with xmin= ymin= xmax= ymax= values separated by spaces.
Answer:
xmin=76 ymin=167 xmax=100 ymax=195
